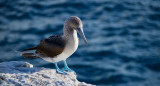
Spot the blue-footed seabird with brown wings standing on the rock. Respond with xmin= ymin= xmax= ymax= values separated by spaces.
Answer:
xmin=21 ymin=16 xmax=88 ymax=74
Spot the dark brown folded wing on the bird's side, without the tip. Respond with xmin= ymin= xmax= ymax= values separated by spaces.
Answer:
xmin=36 ymin=35 xmax=65 ymax=57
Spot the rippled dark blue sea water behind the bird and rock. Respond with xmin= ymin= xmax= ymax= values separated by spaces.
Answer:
xmin=0 ymin=0 xmax=160 ymax=86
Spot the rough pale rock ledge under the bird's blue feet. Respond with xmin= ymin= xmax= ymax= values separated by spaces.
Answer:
xmin=0 ymin=61 xmax=93 ymax=86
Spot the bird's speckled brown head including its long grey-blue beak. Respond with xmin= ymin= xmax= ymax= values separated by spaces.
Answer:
xmin=64 ymin=16 xmax=88 ymax=45
